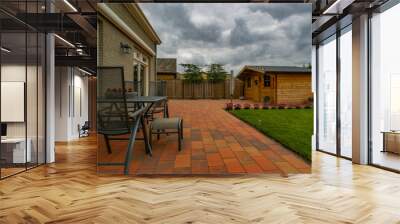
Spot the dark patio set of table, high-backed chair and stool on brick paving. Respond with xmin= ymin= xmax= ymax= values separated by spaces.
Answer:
xmin=97 ymin=67 xmax=183 ymax=175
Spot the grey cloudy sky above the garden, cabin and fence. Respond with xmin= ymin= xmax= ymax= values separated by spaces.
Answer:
xmin=140 ymin=3 xmax=311 ymax=74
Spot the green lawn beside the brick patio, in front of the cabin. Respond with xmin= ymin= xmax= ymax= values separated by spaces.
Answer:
xmin=231 ymin=109 xmax=313 ymax=161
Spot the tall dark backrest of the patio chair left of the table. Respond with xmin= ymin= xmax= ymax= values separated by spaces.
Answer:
xmin=97 ymin=67 xmax=130 ymax=134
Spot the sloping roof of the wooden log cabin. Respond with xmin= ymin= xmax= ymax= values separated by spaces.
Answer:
xmin=236 ymin=65 xmax=311 ymax=79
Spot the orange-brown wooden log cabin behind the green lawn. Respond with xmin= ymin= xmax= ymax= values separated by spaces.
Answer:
xmin=237 ymin=65 xmax=312 ymax=105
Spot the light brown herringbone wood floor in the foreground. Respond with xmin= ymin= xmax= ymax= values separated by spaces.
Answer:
xmin=0 ymin=138 xmax=400 ymax=224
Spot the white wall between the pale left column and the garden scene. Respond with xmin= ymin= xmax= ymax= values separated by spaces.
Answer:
xmin=55 ymin=67 xmax=89 ymax=141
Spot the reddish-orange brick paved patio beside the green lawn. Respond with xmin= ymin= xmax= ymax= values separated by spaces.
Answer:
xmin=98 ymin=100 xmax=310 ymax=175
